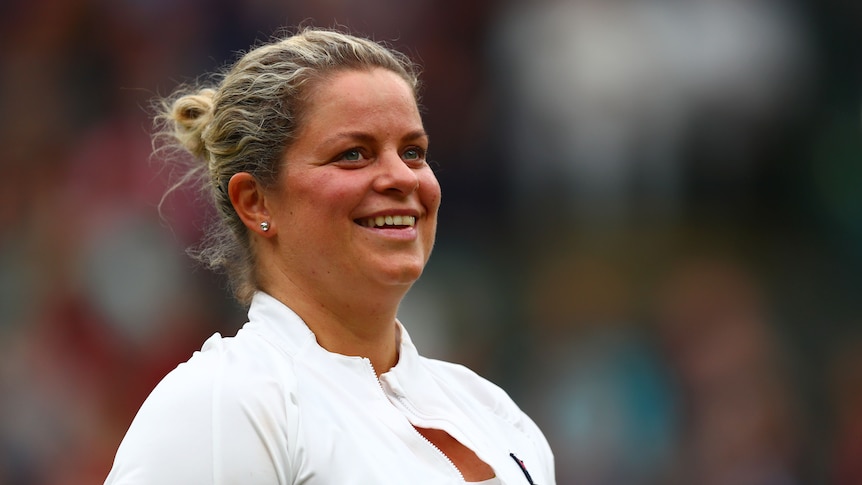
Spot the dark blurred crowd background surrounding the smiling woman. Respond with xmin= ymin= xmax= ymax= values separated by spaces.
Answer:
xmin=0 ymin=0 xmax=862 ymax=485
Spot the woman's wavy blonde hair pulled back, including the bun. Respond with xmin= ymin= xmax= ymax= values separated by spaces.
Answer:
xmin=159 ymin=27 xmax=426 ymax=305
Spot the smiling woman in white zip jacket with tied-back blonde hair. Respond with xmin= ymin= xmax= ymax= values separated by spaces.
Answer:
xmin=106 ymin=29 xmax=554 ymax=485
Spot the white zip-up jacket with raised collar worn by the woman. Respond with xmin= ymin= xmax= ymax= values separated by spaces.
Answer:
xmin=105 ymin=293 xmax=555 ymax=485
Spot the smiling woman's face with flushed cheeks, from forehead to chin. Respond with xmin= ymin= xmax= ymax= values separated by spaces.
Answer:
xmin=264 ymin=68 xmax=440 ymax=295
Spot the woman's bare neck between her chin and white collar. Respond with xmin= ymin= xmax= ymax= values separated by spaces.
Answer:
xmin=264 ymin=272 xmax=403 ymax=375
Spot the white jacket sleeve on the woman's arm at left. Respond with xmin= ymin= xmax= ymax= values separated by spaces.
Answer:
xmin=105 ymin=339 xmax=291 ymax=485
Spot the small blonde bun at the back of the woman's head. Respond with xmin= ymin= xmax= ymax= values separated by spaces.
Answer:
xmin=170 ymin=88 xmax=215 ymax=158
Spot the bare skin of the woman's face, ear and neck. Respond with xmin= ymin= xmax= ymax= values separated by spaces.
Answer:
xmin=228 ymin=68 xmax=440 ymax=373
